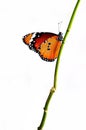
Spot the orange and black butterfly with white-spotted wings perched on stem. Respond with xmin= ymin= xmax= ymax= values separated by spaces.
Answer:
xmin=23 ymin=32 xmax=63 ymax=61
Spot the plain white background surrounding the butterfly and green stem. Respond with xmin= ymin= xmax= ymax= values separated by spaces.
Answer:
xmin=0 ymin=0 xmax=86 ymax=130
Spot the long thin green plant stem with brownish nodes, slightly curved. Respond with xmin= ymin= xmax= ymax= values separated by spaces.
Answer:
xmin=38 ymin=0 xmax=80 ymax=130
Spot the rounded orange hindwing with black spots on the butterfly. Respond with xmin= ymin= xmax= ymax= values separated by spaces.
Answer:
xmin=39 ymin=36 xmax=61 ymax=61
